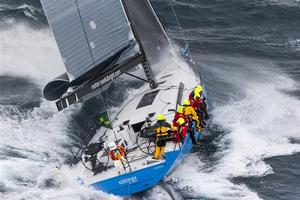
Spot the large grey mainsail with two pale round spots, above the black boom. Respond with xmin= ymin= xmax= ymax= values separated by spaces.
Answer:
xmin=41 ymin=0 xmax=139 ymax=81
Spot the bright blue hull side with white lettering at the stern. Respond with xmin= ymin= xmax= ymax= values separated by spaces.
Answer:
xmin=91 ymin=128 xmax=200 ymax=196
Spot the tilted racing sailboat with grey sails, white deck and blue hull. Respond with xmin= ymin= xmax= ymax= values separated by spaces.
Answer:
xmin=41 ymin=0 xmax=206 ymax=196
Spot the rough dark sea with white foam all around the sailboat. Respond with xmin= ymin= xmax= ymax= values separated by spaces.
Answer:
xmin=0 ymin=0 xmax=300 ymax=200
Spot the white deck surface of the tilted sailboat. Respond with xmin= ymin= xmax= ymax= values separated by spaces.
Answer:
xmin=80 ymin=64 xmax=199 ymax=184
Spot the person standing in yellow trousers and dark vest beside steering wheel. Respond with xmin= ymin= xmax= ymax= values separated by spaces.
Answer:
xmin=152 ymin=114 xmax=176 ymax=160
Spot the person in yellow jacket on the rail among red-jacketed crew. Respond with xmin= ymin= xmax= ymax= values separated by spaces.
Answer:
xmin=183 ymin=99 xmax=201 ymax=144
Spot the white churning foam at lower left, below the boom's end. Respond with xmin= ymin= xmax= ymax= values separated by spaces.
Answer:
xmin=0 ymin=102 xmax=116 ymax=199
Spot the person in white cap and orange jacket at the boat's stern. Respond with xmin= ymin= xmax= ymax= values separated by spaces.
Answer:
xmin=108 ymin=142 xmax=129 ymax=173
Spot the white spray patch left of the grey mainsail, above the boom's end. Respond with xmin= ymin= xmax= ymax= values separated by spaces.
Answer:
xmin=0 ymin=24 xmax=64 ymax=81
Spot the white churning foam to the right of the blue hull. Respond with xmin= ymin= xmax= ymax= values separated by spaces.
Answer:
xmin=170 ymin=59 xmax=300 ymax=200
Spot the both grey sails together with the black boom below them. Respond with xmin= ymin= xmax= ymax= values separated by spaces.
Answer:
xmin=41 ymin=0 xmax=170 ymax=110
